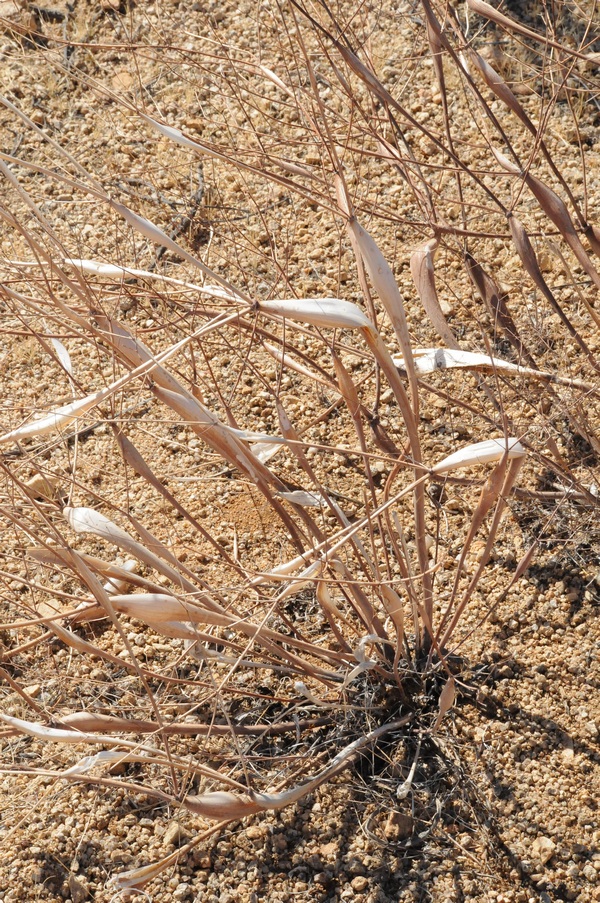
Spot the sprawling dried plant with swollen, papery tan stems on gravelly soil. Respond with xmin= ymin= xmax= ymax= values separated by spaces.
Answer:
xmin=0 ymin=0 xmax=600 ymax=889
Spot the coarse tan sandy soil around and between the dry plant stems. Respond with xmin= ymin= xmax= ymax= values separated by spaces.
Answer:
xmin=0 ymin=0 xmax=600 ymax=903
